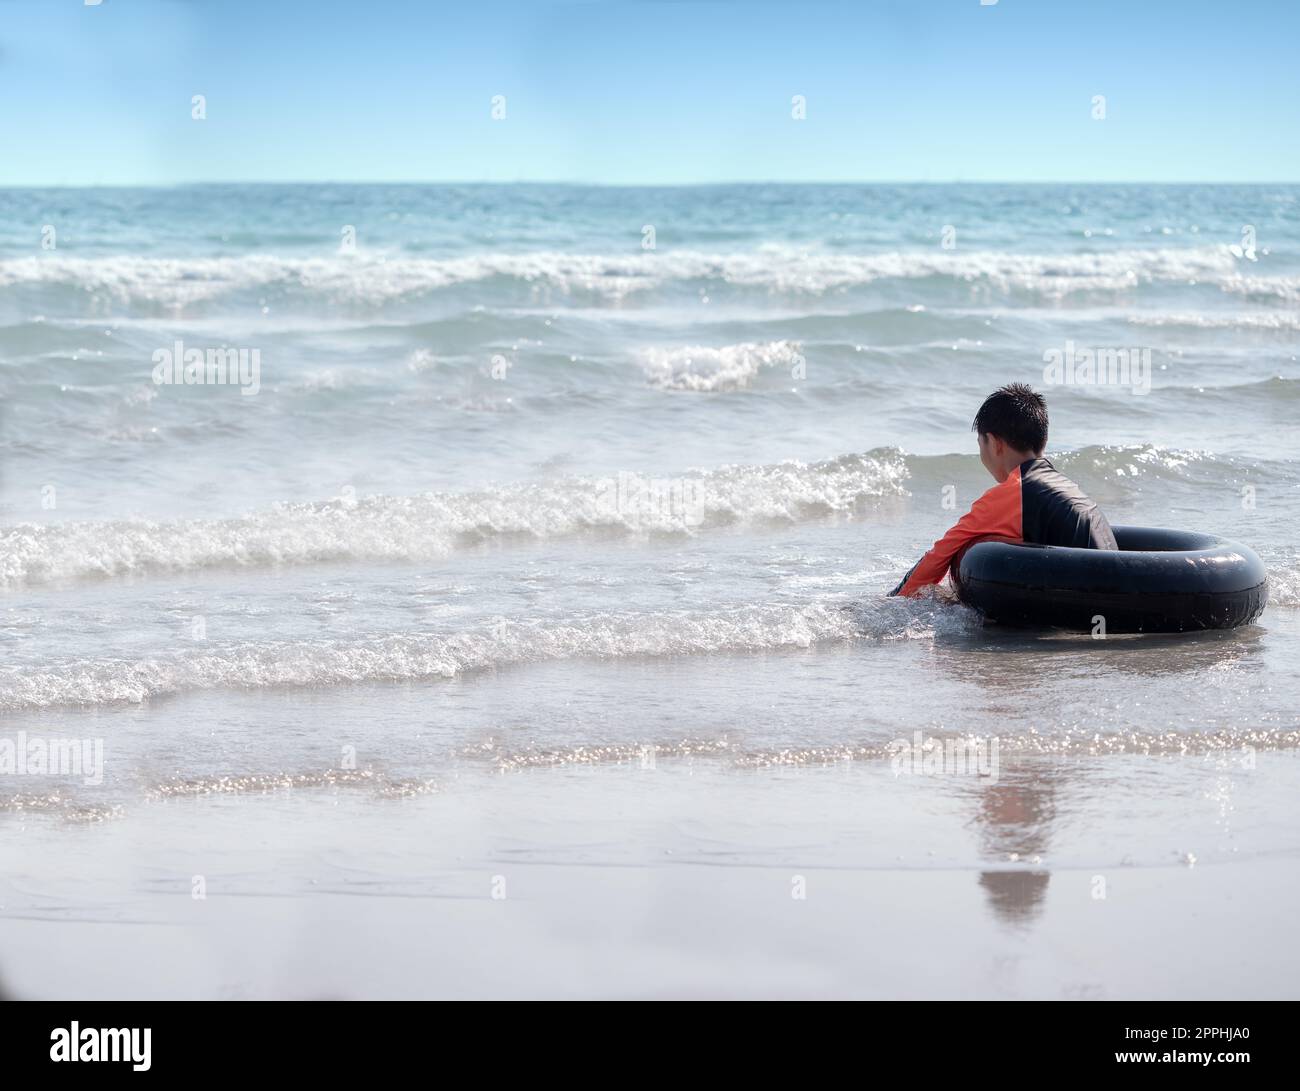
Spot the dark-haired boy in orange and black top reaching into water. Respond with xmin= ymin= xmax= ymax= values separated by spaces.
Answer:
xmin=889 ymin=382 xmax=1119 ymax=596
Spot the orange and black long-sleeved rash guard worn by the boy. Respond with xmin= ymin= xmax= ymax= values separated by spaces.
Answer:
xmin=891 ymin=458 xmax=1119 ymax=594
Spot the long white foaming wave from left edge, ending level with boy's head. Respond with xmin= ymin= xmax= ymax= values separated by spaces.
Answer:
xmin=0 ymin=449 xmax=907 ymax=588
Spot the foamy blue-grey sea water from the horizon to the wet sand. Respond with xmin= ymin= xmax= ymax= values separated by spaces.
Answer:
xmin=0 ymin=186 xmax=1300 ymax=998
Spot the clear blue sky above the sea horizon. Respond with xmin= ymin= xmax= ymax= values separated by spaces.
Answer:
xmin=0 ymin=0 xmax=1300 ymax=185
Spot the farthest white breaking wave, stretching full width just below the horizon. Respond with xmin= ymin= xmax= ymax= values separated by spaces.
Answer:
xmin=0 ymin=246 xmax=1279 ymax=311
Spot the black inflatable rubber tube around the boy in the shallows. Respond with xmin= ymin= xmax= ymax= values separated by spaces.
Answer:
xmin=953 ymin=527 xmax=1269 ymax=633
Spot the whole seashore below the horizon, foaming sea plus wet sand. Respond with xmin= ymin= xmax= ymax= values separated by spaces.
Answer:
xmin=0 ymin=185 xmax=1300 ymax=1000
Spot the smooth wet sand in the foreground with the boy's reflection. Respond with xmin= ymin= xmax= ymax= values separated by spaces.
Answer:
xmin=0 ymin=750 xmax=1300 ymax=1000
